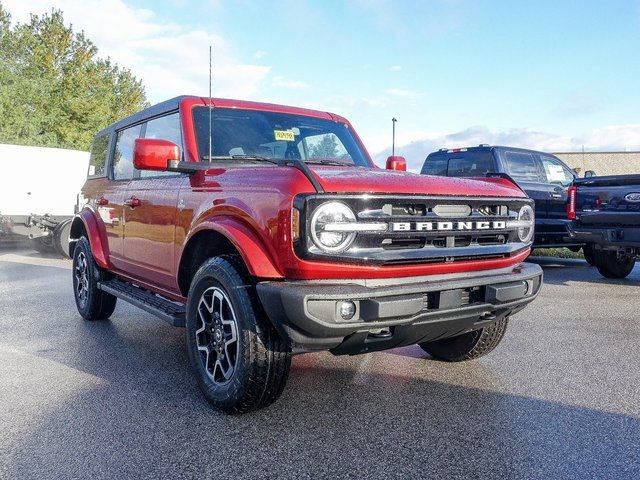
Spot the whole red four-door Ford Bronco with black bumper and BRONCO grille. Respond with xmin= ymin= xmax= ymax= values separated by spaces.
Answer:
xmin=69 ymin=97 xmax=542 ymax=412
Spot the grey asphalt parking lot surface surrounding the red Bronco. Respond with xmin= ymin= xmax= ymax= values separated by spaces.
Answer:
xmin=0 ymin=250 xmax=640 ymax=479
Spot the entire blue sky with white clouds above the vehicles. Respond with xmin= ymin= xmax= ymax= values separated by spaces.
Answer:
xmin=5 ymin=0 xmax=640 ymax=170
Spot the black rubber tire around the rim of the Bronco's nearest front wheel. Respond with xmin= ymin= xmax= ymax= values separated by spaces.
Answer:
xmin=186 ymin=255 xmax=291 ymax=414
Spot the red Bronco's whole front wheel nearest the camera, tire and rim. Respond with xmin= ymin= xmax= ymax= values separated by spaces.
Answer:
xmin=186 ymin=256 xmax=291 ymax=413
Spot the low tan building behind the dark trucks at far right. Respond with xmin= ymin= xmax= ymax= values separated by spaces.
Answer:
xmin=554 ymin=152 xmax=640 ymax=177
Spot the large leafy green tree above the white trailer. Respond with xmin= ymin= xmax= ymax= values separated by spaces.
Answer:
xmin=0 ymin=3 xmax=147 ymax=150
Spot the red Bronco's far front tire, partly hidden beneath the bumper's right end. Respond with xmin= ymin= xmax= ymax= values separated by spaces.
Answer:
xmin=419 ymin=317 xmax=509 ymax=362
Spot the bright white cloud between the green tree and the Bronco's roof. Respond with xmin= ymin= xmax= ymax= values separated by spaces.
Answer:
xmin=3 ymin=0 xmax=270 ymax=103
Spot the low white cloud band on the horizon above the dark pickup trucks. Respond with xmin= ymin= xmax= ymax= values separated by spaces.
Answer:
xmin=373 ymin=124 xmax=640 ymax=171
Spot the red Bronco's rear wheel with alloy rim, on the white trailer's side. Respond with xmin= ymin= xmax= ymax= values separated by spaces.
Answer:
xmin=72 ymin=237 xmax=117 ymax=321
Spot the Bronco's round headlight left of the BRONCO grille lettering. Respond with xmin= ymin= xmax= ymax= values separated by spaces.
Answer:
xmin=311 ymin=202 xmax=356 ymax=253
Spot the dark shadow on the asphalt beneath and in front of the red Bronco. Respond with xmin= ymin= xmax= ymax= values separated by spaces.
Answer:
xmin=2 ymin=312 xmax=640 ymax=478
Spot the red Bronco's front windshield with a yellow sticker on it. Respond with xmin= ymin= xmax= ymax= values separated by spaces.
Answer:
xmin=193 ymin=107 xmax=371 ymax=167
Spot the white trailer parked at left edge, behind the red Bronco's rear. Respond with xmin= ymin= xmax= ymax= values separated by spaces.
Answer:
xmin=0 ymin=144 xmax=89 ymax=256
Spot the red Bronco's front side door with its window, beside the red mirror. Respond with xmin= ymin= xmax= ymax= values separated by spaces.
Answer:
xmin=124 ymin=112 xmax=188 ymax=289
